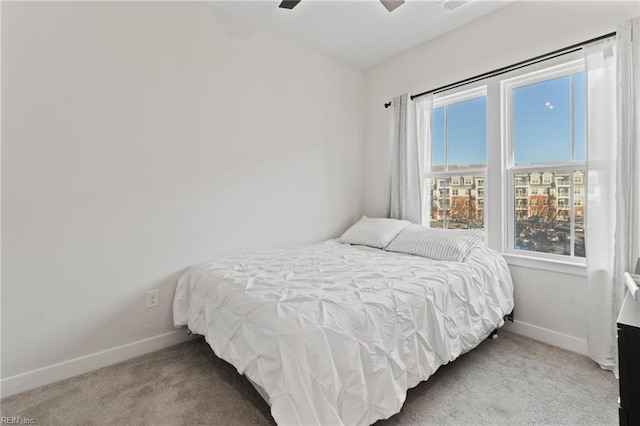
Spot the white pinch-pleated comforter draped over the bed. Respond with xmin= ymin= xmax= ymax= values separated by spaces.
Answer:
xmin=173 ymin=241 xmax=513 ymax=425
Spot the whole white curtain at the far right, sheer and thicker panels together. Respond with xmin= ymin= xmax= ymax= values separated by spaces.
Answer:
xmin=584 ymin=19 xmax=640 ymax=375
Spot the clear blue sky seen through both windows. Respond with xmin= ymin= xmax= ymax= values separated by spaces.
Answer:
xmin=431 ymin=73 xmax=586 ymax=167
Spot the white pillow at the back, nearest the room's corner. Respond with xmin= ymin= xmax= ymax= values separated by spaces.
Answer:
xmin=337 ymin=216 xmax=411 ymax=249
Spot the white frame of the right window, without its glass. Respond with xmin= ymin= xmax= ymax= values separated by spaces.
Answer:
xmin=500 ymin=58 xmax=586 ymax=265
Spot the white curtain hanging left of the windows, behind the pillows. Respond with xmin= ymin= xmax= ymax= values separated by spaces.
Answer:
xmin=389 ymin=94 xmax=424 ymax=223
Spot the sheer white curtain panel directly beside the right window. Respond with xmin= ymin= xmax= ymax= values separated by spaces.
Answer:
xmin=584 ymin=38 xmax=617 ymax=370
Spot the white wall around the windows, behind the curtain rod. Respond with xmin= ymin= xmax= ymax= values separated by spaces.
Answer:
xmin=364 ymin=1 xmax=640 ymax=353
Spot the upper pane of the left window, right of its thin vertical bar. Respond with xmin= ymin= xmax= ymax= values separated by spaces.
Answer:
xmin=446 ymin=97 xmax=487 ymax=170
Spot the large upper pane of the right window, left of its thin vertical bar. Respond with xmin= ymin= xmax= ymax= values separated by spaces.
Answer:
xmin=512 ymin=76 xmax=571 ymax=164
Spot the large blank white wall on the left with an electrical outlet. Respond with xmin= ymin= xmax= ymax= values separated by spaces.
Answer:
xmin=2 ymin=2 xmax=363 ymax=395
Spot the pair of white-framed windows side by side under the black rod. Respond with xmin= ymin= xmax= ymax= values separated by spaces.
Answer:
xmin=423 ymin=51 xmax=587 ymax=265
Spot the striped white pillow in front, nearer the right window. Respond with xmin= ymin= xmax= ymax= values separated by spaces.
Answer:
xmin=386 ymin=225 xmax=484 ymax=262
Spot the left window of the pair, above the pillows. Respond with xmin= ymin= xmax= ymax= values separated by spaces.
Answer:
xmin=423 ymin=86 xmax=487 ymax=229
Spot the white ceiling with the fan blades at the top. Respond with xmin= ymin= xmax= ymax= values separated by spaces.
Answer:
xmin=210 ymin=0 xmax=515 ymax=69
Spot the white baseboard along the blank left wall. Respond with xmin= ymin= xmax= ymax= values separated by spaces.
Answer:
xmin=0 ymin=330 xmax=191 ymax=398
